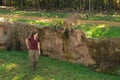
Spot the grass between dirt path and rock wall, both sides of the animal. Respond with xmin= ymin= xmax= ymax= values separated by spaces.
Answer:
xmin=9 ymin=19 xmax=120 ymax=38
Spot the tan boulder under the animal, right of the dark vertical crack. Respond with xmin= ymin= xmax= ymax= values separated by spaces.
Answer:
xmin=63 ymin=30 xmax=95 ymax=66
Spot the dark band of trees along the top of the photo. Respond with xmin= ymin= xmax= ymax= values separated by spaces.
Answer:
xmin=0 ymin=0 xmax=120 ymax=12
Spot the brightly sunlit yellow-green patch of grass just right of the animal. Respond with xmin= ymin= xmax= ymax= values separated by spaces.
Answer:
xmin=80 ymin=24 xmax=110 ymax=38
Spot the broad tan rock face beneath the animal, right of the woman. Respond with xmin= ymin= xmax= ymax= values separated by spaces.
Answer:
xmin=41 ymin=29 xmax=95 ymax=66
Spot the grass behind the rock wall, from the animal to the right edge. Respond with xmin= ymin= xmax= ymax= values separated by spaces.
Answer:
xmin=77 ymin=24 xmax=120 ymax=38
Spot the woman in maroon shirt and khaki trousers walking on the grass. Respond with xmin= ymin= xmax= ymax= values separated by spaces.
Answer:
xmin=26 ymin=32 xmax=40 ymax=70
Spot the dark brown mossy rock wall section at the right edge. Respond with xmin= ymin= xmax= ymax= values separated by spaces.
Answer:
xmin=87 ymin=38 xmax=120 ymax=71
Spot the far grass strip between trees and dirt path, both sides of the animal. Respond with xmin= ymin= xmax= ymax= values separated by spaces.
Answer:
xmin=0 ymin=9 xmax=120 ymax=22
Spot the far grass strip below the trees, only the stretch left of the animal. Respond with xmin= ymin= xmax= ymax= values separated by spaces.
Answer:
xmin=0 ymin=9 xmax=71 ymax=18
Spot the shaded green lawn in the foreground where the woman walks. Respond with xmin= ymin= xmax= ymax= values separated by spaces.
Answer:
xmin=0 ymin=51 xmax=120 ymax=80
